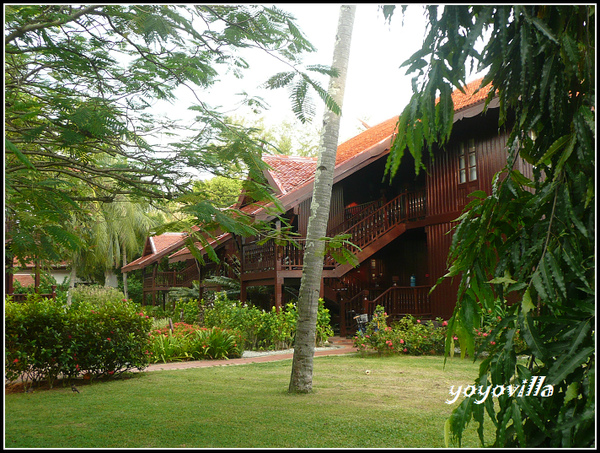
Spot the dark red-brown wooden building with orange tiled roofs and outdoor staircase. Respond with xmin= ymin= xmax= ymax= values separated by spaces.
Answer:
xmin=122 ymin=79 xmax=530 ymax=335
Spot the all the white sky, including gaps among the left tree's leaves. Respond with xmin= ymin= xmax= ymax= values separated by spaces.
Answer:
xmin=157 ymin=3 xmax=434 ymax=143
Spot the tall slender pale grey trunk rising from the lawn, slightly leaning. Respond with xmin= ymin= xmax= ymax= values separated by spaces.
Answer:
xmin=289 ymin=5 xmax=356 ymax=393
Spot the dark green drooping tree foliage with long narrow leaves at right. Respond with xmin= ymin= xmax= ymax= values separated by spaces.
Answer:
xmin=384 ymin=5 xmax=596 ymax=447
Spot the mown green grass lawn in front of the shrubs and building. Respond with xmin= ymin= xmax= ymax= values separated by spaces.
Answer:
xmin=5 ymin=355 xmax=490 ymax=448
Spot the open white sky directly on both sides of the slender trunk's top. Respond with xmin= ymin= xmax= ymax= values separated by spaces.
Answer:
xmin=264 ymin=3 xmax=426 ymax=141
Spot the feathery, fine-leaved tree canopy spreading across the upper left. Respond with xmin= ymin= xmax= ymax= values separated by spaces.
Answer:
xmin=5 ymin=4 xmax=331 ymax=268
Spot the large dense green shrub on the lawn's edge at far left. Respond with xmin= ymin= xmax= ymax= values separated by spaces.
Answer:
xmin=5 ymin=294 xmax=152 ymax=385
